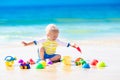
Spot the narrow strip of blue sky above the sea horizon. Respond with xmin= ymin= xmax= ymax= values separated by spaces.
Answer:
xmin=0 ymin=0 xmax=120 ymax=6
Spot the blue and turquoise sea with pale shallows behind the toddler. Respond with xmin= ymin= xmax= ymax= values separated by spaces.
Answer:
xmin=0 ymin=4 xmax=120 ymax=44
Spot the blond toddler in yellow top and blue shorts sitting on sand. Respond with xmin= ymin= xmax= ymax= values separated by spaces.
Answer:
xmin=22 ymin=24 xmax=81 ymax=62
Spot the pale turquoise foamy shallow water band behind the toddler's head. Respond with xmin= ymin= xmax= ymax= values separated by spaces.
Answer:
xmin=0 ymin=22 xmax=120 ymax=41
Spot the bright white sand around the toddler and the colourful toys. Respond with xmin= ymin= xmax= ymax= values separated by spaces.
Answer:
xmin=0 ymin=38 xmax=120 ymax=80
